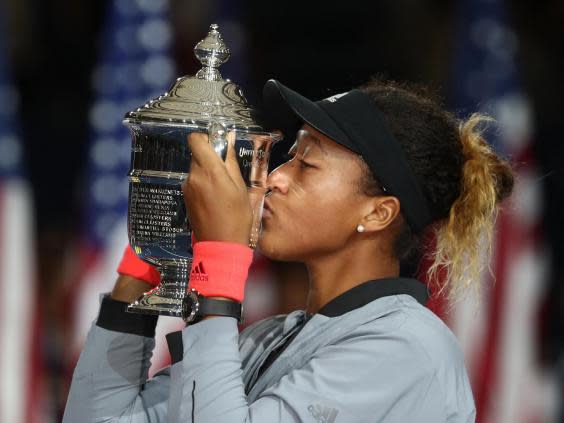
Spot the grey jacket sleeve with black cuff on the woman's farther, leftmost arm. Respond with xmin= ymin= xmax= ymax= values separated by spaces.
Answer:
xmin=63 ymin=296 xmax=170 ymax=423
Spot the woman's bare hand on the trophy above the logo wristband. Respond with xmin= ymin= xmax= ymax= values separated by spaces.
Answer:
xmin=182 ymin=132 xmax=253 ymax=245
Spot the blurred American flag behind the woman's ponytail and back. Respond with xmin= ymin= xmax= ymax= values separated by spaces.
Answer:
xmin=434 ymin=0 xmax=557 ymax=423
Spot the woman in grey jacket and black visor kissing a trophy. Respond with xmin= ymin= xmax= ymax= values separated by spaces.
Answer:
xmin=65 ymin=81 xmax=513 ymax=423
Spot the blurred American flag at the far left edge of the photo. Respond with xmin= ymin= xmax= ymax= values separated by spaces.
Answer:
xmin=0 ymin=4 xmax=44 ymax=423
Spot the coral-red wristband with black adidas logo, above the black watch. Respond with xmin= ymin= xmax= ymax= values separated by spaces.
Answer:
xmin=188 ymin=241 xmax=253 ymax=302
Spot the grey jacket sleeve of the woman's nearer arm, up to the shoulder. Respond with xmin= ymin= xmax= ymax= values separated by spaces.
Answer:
xmin=171 ymin=317 xmax=466 ymax=423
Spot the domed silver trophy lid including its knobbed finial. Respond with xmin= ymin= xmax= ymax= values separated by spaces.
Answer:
xmin=124 ymin=24 xmax=264 ymax=132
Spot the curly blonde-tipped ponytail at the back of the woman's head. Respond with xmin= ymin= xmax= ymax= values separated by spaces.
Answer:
xmin=427 ymin=114 xmax=513 ymax=299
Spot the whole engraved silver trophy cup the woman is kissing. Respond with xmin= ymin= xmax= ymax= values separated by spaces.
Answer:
xmin=124 ymin=24 xmax=280 ymax=317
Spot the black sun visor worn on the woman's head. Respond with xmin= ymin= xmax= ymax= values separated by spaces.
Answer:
xmin=263 ymin=79 xmax=431 ymax=233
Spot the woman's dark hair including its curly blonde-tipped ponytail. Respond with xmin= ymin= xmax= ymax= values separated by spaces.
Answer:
xmin=360 ymin=78 xmax=513 ymax=300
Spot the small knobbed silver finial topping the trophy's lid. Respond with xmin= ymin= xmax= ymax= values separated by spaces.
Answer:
xmin=194 ymin=24 xmax=231 ymax=81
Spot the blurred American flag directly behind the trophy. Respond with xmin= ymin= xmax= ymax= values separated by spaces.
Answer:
xmin=68 ymin=0 xmax=179 ymax=378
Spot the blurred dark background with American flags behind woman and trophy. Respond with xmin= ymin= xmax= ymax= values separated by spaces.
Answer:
xmin=0 ymin=0 xmax=564 ymax=423
